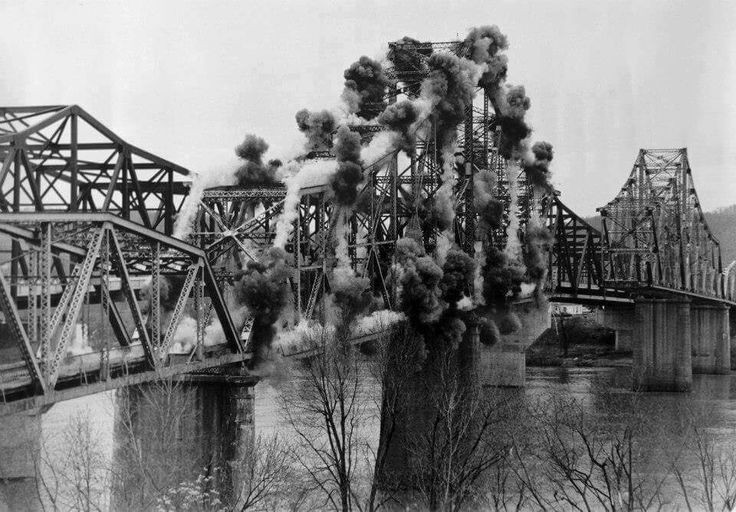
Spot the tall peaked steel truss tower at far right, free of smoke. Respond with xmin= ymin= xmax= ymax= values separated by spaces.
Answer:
xmin=599 ymin=148 xmax=723 ymax=296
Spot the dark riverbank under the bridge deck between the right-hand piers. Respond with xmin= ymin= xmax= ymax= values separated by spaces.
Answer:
xmin=526 ymin=313 xmax=632 ymax=368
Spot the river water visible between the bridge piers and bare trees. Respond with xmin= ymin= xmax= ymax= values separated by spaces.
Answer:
xmin=42 ymin=367 xmax=736 ymax=509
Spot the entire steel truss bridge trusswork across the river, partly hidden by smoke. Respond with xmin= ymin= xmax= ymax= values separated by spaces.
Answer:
xmin=0 ymin=42 xmax=736 ymax=414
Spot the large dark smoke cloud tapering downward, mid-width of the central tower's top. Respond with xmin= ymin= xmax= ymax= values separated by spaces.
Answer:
xmin=422 ymin=53 xmax=476 ymax=148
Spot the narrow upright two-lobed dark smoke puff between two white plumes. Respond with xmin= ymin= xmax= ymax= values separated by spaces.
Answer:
xmin=332 ymin=125 xmax=363 ymax=206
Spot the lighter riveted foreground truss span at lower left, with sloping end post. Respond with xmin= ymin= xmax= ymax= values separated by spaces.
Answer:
xmin=0 ymin=212 xmax=248 ymax=402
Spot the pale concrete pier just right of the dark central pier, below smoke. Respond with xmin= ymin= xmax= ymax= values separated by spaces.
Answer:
xmin=479 ymin=301 xmax=552 ymax=387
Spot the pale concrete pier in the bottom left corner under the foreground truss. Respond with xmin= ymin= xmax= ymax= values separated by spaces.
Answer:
xmin=0 ymin=413 xmax=42 ymax=512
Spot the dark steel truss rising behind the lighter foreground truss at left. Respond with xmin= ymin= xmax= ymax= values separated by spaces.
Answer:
xmin=0 ymin=105 xmax=191 ymax=234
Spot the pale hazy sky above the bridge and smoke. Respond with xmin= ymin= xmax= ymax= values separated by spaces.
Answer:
xmin=0 ymin=0 xmax=736 ymax=214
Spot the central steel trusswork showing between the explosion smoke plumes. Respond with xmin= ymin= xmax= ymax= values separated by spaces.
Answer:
xmin=193 ymin=42 xmax=551 ymax=318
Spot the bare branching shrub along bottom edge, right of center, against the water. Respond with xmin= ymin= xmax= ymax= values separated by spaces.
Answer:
xmin=508 ymin=396 xmax=667 ymax=511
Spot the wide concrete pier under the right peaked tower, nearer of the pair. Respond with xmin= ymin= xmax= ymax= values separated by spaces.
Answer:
xmin=633 ymin=297 xmax=693 ymax=391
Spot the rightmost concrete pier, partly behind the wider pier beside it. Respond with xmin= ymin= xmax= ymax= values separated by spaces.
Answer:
xmin=690 ymin=304 xmax=731 ymax=374
